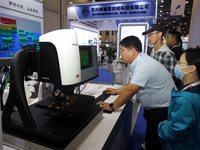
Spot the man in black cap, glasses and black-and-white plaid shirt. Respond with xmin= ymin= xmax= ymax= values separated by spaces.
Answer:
xmin=142 ymin=24 xmax=176 ymax=81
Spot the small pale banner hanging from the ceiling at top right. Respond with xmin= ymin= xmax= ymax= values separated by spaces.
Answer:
xmin=170 ymin=0 xmax=186 ymax=16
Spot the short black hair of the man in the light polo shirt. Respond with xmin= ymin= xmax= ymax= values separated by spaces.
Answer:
xmin=119 ymin=36 xmax=142 ymax=52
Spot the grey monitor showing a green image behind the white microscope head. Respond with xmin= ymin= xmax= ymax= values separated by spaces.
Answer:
xmin=79 ymin=45 xmax=98 ymax=84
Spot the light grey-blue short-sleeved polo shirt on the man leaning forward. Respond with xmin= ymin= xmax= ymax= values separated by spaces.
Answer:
xmin=130 ymin=53 xmax=175 ymax=109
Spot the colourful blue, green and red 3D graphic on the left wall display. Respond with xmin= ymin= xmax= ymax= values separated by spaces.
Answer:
xmin=0 ymin=13 xmax=41 ymax=57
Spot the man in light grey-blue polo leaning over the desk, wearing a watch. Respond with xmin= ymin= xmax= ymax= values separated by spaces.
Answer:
xmin=97 ymin=36 xmax=175 ymax=150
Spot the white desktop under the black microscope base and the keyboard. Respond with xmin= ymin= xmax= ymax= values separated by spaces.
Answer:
xmin=4 ymin=83 xmax=139 ymax=150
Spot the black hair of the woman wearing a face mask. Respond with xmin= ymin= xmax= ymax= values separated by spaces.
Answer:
xmin=184 ymin=48 xmax=200 ymax=79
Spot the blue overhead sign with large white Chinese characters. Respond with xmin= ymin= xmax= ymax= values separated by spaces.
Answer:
xmin=74 ymin=1 xmax=156 ymax=20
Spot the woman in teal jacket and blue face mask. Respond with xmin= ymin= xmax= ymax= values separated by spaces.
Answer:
xmin=158 ymin=48 xmax=200 ymax=150
